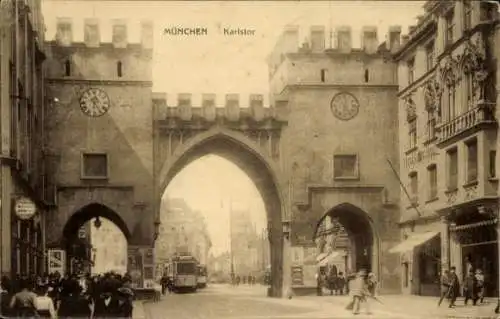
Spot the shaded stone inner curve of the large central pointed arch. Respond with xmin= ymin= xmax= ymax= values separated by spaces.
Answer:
xmin=159 ymin=130 xmax=283 ymax=297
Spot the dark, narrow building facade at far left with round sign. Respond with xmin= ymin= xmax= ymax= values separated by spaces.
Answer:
xmin=0 ymin=0 xmax=51 ymax=275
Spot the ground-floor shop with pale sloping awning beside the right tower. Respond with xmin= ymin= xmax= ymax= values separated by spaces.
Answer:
xmin=389 ymin=229 xmax=441 ymax=296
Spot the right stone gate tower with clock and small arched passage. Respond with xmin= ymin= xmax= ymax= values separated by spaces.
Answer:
xmin=269 ymin=26 xmax=401 ymax=292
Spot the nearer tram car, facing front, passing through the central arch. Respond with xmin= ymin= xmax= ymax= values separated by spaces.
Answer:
xmin=166 ymin=255 xmax=198 ymax=292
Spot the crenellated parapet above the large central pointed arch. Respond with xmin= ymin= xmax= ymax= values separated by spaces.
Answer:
xmin=153 ymin=93 xmax=288 ymax=127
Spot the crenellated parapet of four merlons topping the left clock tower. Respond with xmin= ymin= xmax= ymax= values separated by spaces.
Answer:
xmin=50 ymin=17 xmax=154 ymax=49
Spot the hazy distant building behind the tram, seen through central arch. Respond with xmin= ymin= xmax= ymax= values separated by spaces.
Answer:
xmin=155 ymin=198 xmax=212 ymax=264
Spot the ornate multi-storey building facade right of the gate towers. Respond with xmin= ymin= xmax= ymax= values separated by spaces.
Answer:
xmin=392 ymin=0 xmax=500 ymax=296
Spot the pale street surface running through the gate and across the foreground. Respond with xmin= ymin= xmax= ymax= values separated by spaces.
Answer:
xmin=134 ymin=285 xmax=497 ymax=319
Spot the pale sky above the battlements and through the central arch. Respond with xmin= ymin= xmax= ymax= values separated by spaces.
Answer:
xmin=42 ymin=0 xmax=424 ymax=253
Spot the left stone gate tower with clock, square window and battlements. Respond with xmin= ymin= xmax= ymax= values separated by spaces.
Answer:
xmin=44 ymin=18 xmax=155 ymax=282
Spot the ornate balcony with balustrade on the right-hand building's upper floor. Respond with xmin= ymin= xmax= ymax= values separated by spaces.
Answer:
xmin=436 ymin=101 xmax=497 ymax=147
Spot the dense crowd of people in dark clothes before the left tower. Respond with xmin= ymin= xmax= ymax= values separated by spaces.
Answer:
xmin=0 ymin=272 xmax=134 ymax=319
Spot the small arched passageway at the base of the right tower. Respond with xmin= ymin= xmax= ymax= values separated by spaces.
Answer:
xmin=314 ymin=203 xmax=378 ymax=274
